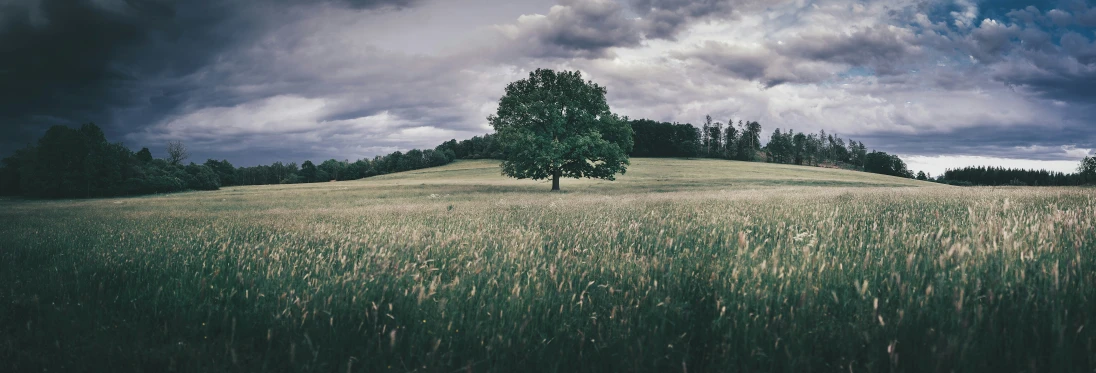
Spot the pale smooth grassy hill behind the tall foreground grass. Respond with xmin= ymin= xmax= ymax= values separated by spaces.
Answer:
xmin=147 ymin=158 xmax=933 ymax=207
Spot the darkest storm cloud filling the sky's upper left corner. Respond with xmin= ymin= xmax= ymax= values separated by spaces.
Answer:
xmin=0 ymin=0 xmax=418 ymax=154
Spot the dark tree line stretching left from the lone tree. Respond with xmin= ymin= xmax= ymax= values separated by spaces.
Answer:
xmin=0 ymin=123 xmax=517 ymax=199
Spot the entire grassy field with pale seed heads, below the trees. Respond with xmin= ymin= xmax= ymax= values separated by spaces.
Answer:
xmin=0 ymin=159 xmax=1096 ymax=372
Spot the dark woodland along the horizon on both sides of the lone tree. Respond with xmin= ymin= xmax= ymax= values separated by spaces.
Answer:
xmin=0 ymin=120 xmax=1096 ymax=197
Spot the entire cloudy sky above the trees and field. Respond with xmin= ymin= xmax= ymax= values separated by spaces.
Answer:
xmin=0 ymin=0 xmax=1096 ymax=173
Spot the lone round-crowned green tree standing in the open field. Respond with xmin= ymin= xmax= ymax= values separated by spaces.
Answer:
xmin=488 ymin=69 xmax=632 ymax=191
